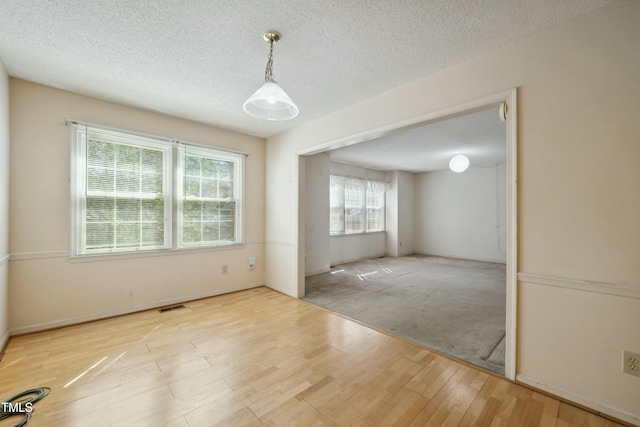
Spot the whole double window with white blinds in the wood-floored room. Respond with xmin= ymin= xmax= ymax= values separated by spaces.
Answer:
xmin=72 ymin=124 xmax=243 ymax=255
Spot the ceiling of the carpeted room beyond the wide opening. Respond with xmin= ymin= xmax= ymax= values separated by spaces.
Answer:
xmin=330 ymin=107 xmax=507 ymax=173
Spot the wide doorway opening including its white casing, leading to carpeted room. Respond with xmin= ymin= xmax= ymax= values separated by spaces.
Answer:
xmin=298 ymin=89 xmax=517 ymax=379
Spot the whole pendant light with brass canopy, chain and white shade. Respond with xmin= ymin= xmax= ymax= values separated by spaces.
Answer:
xmin=243 ymin=31 xmax=298 ymax=120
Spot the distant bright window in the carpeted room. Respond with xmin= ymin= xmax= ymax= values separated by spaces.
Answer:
xmin=329 ymin=175 xmax=386 ymax=235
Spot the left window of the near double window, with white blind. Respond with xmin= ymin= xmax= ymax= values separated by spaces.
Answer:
xmin=75 ymin=126 xmax=171 ymax=254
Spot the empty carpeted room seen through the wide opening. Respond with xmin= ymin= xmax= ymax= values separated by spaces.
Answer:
xmin=305 ymin=106 xmax=507 ymax=374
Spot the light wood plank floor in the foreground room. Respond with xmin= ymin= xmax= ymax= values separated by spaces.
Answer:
xmin=0 ymin=288 xmax=619 ymax=427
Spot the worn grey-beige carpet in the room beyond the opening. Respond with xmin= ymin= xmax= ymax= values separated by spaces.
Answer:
xmin=305 ymin=255 xmax=506 ymax=375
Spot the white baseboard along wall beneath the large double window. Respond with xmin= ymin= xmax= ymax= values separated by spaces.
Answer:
xmin=9 ymin=282 xmax=264 ymax=336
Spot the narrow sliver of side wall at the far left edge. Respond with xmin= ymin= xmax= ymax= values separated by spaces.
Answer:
xmin=0 ymin=62 xmax=9 ymax=351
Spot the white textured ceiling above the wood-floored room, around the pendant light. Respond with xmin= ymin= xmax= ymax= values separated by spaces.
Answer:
xmin=0 ymin=0 xmax=610 ymax=137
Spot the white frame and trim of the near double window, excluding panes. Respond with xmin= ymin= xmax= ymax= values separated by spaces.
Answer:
xmin=70 ymin=119 xmax=248 ymax=259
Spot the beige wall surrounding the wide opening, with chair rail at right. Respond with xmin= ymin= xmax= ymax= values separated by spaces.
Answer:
xmin=266 ymin=1 xmax=640 ymax=423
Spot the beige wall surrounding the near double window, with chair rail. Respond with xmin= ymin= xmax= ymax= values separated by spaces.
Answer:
xmin=10 ymin=79 xmax=265 ymax=333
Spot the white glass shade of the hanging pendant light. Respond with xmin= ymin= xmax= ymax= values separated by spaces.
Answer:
xmin=243 ymin=81 xmax=298 ymax=120
